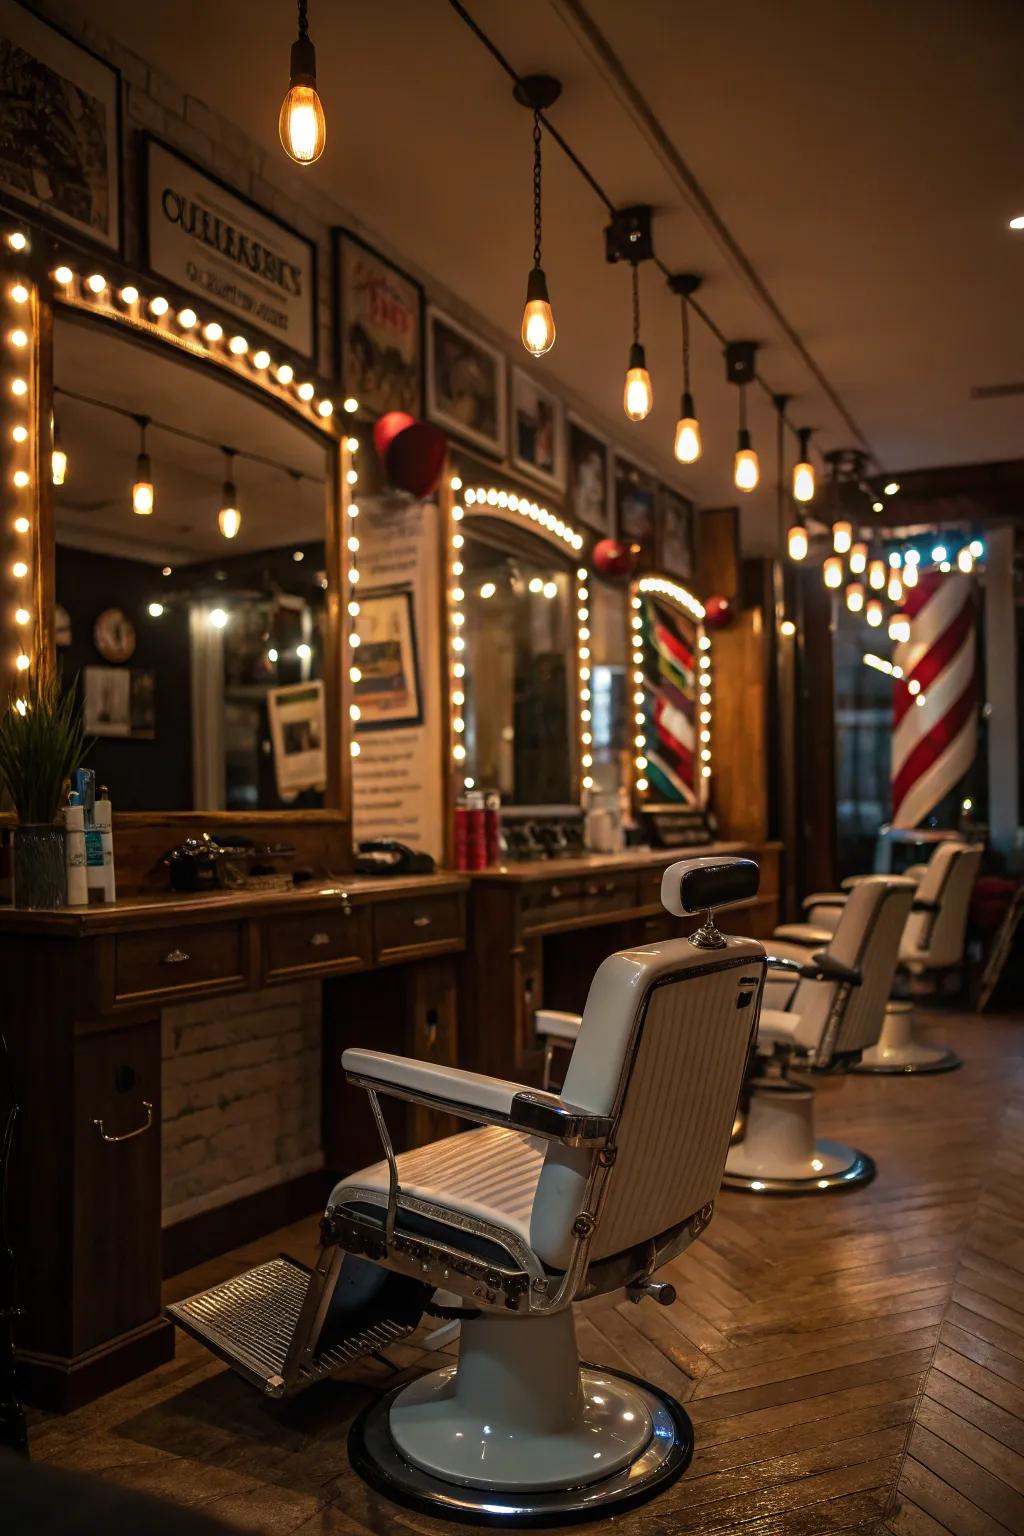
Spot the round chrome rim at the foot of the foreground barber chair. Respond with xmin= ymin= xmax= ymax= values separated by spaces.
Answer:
xmin=348 ymin=1366 xmax=694 ymax=1528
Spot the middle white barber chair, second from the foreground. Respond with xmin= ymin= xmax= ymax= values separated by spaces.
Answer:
xmin=723 ymin=876 xmax=917 ymax=1195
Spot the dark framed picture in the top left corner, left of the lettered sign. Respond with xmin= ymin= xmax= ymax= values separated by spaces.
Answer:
xmin=0 ymin=0 xmax=121 ymax=250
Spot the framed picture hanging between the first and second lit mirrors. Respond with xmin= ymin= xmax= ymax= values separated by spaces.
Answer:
xmin=355 ymin=587 xmax=424 ymax=731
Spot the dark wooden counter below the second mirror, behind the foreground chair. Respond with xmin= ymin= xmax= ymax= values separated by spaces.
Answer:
xmin=459 ymin=842 xmax=781 ymax=1081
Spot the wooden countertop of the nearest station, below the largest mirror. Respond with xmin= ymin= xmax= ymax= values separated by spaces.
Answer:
xmin=0 ymin=871 xmax=468 ymax=935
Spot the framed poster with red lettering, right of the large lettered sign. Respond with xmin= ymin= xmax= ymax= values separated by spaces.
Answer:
xmin=333 ymin=229 xmax=424 ymax=416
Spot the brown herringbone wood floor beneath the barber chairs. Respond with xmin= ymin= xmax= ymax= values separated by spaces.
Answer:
xmin=23 ymin=1015 xmax=1024 ymax=1536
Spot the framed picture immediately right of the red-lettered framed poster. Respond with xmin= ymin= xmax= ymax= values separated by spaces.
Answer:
xmin=427 ymin=304 xmax=508 ymax=458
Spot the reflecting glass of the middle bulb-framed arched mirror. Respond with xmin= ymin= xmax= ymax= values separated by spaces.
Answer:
xmin=461 ymin=527 xmax=576 ymax=805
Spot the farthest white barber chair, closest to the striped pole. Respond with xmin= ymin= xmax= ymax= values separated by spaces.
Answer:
xmin=772 ymin=842 xmax=984 ymax=1074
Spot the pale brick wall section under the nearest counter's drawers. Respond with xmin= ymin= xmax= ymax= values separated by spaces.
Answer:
xmin=163 ymin=982 xmax=324 ymax=1226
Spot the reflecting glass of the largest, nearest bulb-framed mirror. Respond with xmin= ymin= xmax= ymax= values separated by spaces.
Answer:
xmin=54 ymin=315 xmax=332 ymax=811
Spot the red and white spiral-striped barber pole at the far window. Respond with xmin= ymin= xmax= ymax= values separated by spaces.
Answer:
xmin=892 ymin=571 xmax=978 ymax=826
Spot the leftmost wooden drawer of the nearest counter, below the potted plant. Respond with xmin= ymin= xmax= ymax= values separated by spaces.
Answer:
xmin=114 ymin=923 xmax=246 ymax=1003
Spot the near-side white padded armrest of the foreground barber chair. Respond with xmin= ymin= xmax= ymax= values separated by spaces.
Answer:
xmin=341 ymin=1049 xmax=613 ymax=1147
